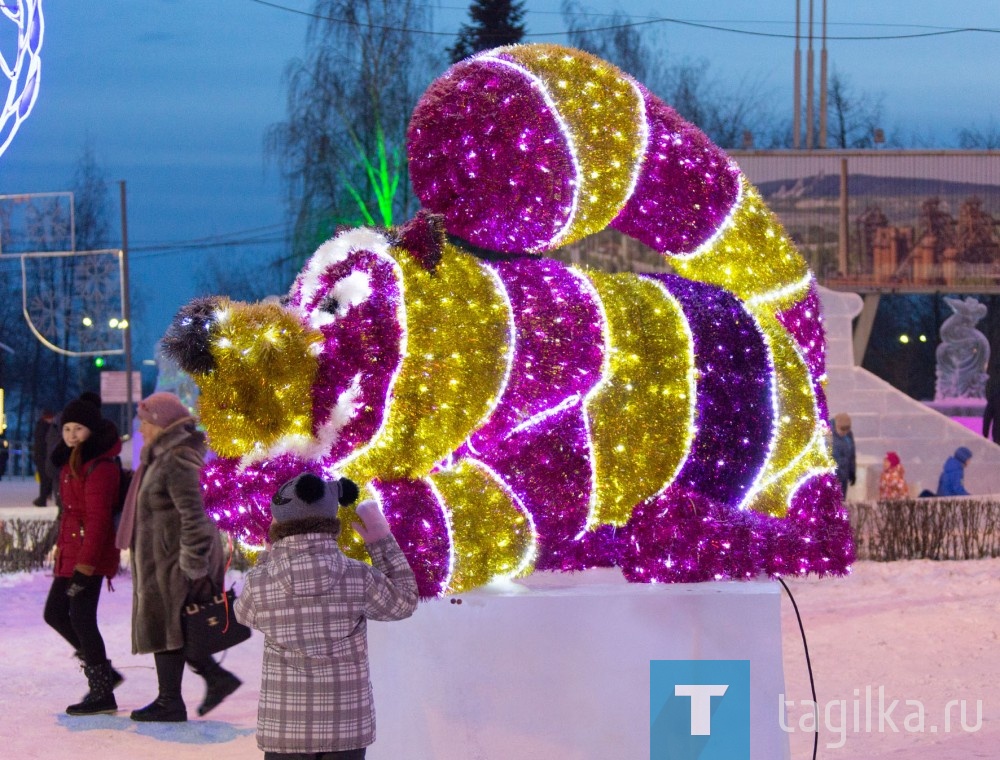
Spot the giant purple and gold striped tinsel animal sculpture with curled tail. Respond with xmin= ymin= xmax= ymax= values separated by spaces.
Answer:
xmin=165 ymin=45 xmax=853 ymax=596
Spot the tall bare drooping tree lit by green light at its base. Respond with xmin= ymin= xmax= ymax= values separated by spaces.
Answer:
xmin=266 ymin=0 xmax=440 ymax=265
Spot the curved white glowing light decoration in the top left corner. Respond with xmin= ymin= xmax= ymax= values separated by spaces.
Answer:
xmin=0 ymin=0 xmax=44 ymax=156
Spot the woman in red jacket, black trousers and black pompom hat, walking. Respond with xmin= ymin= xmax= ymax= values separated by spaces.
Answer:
xmin=45 ymin=397 xmax=123 ymax=715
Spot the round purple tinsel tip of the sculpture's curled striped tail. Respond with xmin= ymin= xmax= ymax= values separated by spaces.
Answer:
xmin=407 ymin=60 xmax=576 ymax=252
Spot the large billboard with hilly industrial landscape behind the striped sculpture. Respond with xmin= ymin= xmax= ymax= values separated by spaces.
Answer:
xmin=555 ymin=150 xmax=1000 ymax=293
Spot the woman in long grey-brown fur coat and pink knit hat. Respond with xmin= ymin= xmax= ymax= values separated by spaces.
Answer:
xmin=118 ymin=393 xmax=241 ymax=722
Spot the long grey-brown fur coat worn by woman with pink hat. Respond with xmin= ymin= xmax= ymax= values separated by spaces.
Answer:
xmin=131 ymin=417 xmax=225 ymax=654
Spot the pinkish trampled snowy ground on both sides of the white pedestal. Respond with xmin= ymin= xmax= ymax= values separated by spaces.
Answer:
xmin=0 ymin=480 xmax=1000 ymax=760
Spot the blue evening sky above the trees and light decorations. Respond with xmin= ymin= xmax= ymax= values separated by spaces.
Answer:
xmin=0 ymin=0 xmax=1000 ymax=361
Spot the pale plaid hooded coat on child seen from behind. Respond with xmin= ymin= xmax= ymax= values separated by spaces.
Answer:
xmin=234 ymin=533 xmax=417 ymax=753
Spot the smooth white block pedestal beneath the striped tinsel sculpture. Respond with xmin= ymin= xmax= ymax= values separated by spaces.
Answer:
xmin=367 ymin=570 xmax=788 ymax=760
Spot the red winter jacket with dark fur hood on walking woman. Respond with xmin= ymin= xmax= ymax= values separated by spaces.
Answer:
xmin=52 ymin=420 xmax=122 ymax=578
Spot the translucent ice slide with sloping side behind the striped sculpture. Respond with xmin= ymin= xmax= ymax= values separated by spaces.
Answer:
xmin=819 ymin=288 xmax=1000 ymax=500
